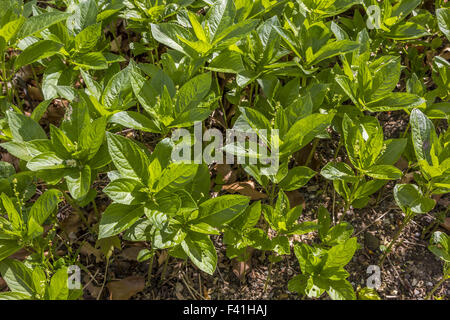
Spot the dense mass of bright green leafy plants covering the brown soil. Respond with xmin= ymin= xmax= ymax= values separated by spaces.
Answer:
xmin=0 ymin=0 xmax=450 ymax=299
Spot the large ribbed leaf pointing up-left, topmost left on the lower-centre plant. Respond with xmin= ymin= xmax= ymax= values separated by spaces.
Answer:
xmin=106 ymin=132 xmax=149 ymax=184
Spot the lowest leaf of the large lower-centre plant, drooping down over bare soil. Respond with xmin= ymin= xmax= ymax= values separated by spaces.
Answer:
xmin=181 ymin=232 xmax=217 ymax=275
